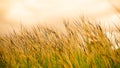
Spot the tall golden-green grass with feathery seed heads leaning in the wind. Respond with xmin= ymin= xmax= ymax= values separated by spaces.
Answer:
xmin=0 ymin=19 xmax=120 ymax=68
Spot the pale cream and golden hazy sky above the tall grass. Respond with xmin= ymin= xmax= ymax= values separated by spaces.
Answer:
xmin=0 ymin=0 xmax=119 ymax=33
